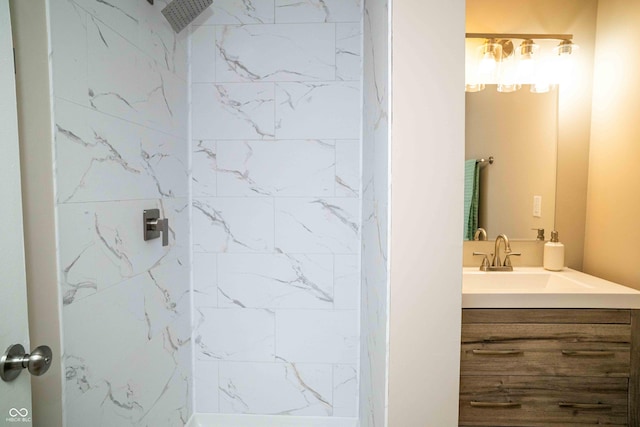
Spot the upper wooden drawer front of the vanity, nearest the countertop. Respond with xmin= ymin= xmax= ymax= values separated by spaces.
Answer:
xmin=460 ymin=324 xmax=631 ymax=377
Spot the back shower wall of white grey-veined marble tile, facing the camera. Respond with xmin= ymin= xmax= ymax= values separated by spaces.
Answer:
xmin=191 ymin=0 xmax=362 ymax=417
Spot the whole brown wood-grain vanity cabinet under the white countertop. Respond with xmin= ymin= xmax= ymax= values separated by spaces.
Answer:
xmin=459 ymin=309 xmax=640 ymax=427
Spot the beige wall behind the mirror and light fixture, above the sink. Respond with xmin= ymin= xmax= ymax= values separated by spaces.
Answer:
xmin=465 ymin=0 xmax=598 ymax=270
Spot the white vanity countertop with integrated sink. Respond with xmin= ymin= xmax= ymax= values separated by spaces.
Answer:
xmin=462 ymin=267 xmax=640 ymax=309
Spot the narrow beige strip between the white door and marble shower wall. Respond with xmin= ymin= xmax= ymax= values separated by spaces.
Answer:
xmin=10 ymin=0 xmax=64 ymax=427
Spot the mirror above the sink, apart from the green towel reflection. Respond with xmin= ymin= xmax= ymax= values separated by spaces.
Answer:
xmin=465 ymin=85 xmax=558 ymax=240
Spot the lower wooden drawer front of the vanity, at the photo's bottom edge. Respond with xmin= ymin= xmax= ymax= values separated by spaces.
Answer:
xmin=460 ymin=376 xmax=628 ymax=426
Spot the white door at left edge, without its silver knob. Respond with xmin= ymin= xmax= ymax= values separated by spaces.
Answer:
xmin=0 ymin=0 xmax=31 ymax=426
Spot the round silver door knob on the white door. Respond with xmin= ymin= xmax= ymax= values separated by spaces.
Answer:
xmin=0 ymin=344 xmax=53 ymax=382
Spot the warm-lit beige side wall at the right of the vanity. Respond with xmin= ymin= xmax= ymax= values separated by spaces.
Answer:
xmin=584 ymin=0 xmax=640 ymax=289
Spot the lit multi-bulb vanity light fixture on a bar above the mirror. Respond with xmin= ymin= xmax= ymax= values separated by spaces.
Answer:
xmin=465 ymin=33 xmax=578 ymax=93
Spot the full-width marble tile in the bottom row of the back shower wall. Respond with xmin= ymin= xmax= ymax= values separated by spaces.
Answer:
xmin=219 ymin=360 xmax=333 ymax=416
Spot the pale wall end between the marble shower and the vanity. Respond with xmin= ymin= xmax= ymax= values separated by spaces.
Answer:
xmin=388 ymin=0 xmax=464 ymax=427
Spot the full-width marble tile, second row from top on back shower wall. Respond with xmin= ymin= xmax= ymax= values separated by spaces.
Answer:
xmin=215 ymin=24 xmax=336 ymax=82
